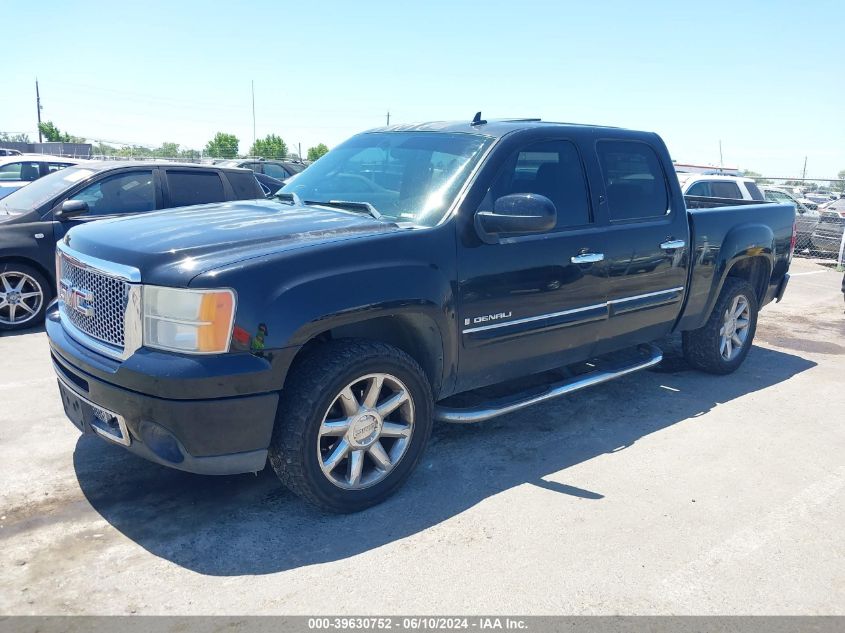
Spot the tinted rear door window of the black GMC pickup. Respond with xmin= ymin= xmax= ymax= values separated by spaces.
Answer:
xmin=596 ymin=140 xmax=669 ymax=222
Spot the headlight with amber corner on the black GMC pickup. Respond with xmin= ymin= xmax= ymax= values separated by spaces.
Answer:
xmin=142 ymin=286 xmax=235 ymax=354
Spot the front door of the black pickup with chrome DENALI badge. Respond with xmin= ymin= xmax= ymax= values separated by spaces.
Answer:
xmin=457 ymin=138 xmax=608 ymax=391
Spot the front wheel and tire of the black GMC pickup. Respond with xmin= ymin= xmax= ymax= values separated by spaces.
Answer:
xmin=269 ymin=339 xmax=432 ymax=512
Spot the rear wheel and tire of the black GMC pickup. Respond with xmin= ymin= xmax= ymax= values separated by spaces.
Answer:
xmin=683 ymin=277 xmax=759 ymax=374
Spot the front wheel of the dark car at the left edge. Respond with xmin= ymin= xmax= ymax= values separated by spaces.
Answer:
xmin=0 ymin=262 xmax=52 ymax=332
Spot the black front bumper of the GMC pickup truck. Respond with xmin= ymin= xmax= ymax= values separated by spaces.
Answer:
xmin=46 ymin=310 xmax=279 ymax=475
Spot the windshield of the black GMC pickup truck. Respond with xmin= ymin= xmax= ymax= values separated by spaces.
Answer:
xmin=280 ymin=132 xmax=493 ymax=226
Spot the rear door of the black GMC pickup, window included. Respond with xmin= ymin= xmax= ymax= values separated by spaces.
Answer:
xmin=595 ymin=138 xmax=689 ymax=353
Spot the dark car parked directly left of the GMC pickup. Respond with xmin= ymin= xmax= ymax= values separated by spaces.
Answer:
xmin=0 ymin=162 xmax=264 ymax=330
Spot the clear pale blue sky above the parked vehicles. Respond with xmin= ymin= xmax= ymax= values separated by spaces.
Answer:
xmin=0 ymin=0 xmax=845 ymax=178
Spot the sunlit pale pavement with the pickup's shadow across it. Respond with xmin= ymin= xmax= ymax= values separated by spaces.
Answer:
xmin=0 ymin=260 xmax=845 ymax=614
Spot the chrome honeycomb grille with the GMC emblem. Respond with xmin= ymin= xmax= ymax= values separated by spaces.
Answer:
xmin=59 ymin=255 xmax=130 ymax=350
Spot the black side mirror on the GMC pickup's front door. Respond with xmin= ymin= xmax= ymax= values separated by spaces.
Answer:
xmin=475 ymin=193 xmax=557 ymax=244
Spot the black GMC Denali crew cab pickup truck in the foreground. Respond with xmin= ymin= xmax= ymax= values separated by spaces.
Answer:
xmin=46 ymin=116 xmax=795 ymax=512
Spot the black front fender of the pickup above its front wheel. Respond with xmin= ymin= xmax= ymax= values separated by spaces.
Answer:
xmin=191 ymin=223 xmax=458 ymax=398
